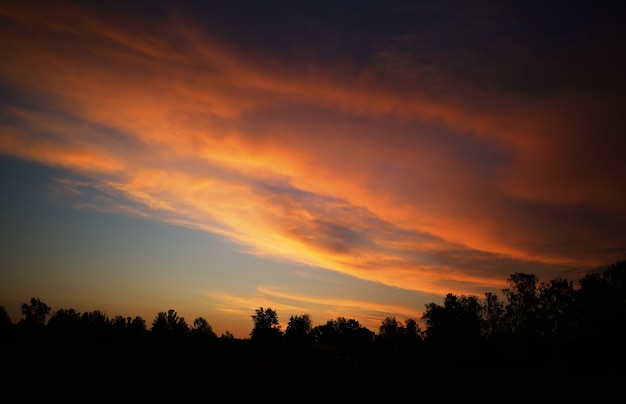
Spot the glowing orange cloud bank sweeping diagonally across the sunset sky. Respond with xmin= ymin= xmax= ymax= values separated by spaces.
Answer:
xmin=0 ymin=2 xmax=626 ymax=334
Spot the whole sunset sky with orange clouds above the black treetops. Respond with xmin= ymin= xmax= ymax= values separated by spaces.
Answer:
xmin=0 ymin=0 xmax=626 ymax=338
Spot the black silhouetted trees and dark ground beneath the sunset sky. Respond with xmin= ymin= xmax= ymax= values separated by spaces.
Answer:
xmin=0 ymin=261 xmax=626 ymax=402
